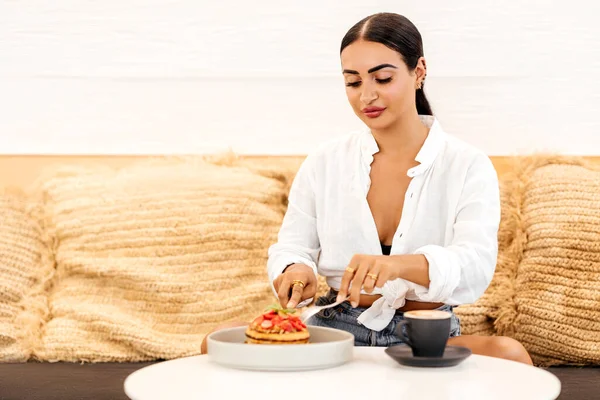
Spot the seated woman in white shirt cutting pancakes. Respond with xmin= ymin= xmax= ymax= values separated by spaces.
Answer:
xmin=268 ymin=13 xmax=531 ymax=364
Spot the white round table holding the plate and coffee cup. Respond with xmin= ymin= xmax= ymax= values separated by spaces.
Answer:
xmin=124 ymin=347 xmax=560 ymax=400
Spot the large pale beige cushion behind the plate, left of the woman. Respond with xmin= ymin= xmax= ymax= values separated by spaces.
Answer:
xmin=36 ymin=160 xmax=286 ymax=361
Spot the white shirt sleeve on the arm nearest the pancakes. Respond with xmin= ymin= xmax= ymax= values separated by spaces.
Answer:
xmin=267 ymin=156 xmax=320 ymax=307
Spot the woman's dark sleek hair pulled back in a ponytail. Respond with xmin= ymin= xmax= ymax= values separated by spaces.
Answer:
xmin=340 ymin=13 xmax=433 ymax=115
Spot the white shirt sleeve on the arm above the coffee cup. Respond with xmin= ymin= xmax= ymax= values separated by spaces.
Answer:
xmin=415 ymin=155 xmax=501 ymax=305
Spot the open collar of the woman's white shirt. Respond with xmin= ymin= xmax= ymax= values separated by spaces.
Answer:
xmin=361 ymin=115 xmax=446 ymax=177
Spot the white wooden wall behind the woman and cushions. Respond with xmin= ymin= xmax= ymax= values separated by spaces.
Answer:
xmin=0 ymin=0 xmax=600 ymax=155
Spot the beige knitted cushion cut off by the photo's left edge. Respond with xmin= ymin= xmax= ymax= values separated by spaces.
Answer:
xmin=0 ymin=191 xmax=53 ymax=362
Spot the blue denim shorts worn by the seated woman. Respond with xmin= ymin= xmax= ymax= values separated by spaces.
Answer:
xmin=307 ymin=290 xmax=460 ymax=347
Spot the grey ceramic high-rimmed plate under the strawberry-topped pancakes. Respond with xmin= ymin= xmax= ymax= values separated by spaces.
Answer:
xmin=207 ymin=326 xmax=354 ymax=371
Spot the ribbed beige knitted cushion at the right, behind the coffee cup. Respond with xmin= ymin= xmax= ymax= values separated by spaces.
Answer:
xmin=496 ymin=158 xmax=600 ymax=365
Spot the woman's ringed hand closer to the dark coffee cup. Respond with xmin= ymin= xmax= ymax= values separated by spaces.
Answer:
xmin=337 ymin=254 xmax=401 ymax=307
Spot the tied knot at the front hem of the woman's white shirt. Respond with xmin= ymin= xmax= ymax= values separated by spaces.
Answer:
xmin=358 ymin=279 xmax=409 ymax=332
